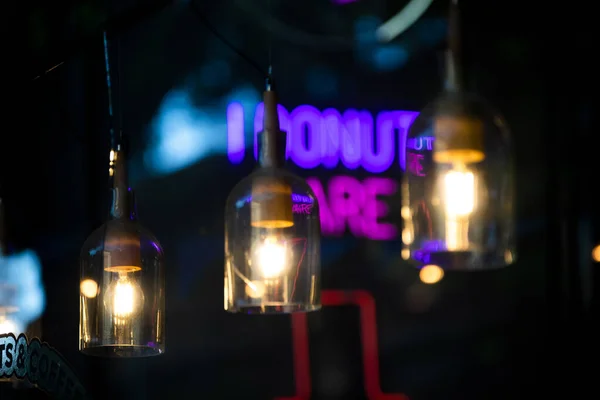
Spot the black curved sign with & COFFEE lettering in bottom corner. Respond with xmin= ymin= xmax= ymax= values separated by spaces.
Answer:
xmin=0 ymin=333 xmax=88 ymax=400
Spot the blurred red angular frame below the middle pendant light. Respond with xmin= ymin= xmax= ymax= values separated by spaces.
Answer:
xmin=275 ymin=290 xmax=408 ymax=400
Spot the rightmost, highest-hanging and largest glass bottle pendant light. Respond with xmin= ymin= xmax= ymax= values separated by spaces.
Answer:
xmin=401 ymin=0 xmax=515 ymax=270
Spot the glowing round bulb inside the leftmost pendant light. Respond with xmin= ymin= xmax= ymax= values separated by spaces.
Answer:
xmin=104 ymin=273 xmax=144 ymax=320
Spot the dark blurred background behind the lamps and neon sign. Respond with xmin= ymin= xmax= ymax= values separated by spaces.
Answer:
xmin=0 ymin=0 xmax=600 ymax=400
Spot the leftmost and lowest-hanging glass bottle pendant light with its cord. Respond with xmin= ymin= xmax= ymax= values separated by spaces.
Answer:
xmin=79 ymin=35 xmax=165 ymax=357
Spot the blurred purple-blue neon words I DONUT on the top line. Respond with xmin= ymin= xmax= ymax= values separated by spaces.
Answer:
xmin=227 ymin=102 xmax=418 ymax=173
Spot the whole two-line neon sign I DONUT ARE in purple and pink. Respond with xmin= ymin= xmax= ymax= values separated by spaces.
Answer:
xmin=227 ymin=102 xmax=426 ymax=240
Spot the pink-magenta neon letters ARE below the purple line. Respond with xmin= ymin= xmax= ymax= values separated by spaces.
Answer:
xmin=307 ymin=175 xmax=397 ymax=240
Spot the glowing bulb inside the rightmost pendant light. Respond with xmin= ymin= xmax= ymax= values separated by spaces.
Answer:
xmin=442 ymin=163 xmax=476 ymax=251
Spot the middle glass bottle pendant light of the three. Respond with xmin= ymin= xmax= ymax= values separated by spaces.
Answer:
xmin=225 ymin=74 xmax=321 ymax=314
